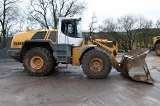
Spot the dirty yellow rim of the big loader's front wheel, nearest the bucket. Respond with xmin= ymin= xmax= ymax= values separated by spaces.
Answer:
xmin=89 ymin=58 xmax=103 ymax=72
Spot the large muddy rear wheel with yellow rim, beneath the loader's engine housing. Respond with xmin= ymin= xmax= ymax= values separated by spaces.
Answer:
xmin=23 ymin=47 xmax=54 ymax=76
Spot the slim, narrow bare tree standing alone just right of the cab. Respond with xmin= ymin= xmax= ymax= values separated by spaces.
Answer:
xmin=89 ymin=13 xmax=97 ymax=36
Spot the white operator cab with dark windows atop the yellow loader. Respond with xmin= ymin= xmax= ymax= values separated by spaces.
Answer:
xmin=58 ymin=17 xmax=83 ymax=46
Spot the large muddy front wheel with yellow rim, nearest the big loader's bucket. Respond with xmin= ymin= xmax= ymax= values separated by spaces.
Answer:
xmin=82 ymin=50 xmax=112 ymax=79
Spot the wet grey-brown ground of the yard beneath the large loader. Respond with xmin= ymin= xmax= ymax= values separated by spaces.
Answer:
xmin=0 ymin=52 xmax=160 ymax=106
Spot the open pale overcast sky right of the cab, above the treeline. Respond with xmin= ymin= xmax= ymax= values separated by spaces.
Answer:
xmin=82 ymin=0 xmax=160 ymax=29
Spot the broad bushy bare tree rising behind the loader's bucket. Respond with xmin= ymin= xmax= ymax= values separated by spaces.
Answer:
xmin=104 ymin=15 xmax=153 ymax=51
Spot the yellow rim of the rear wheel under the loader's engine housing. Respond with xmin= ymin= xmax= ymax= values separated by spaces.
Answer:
xmin=30 ymin=56 xmax=44 ymax=70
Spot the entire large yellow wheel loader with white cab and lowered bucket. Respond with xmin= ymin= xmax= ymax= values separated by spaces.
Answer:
xmin=8 ymin=17 xmax=154 ymax=83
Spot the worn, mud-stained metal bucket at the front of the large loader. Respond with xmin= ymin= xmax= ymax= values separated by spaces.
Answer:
xmin=120 ymin=49 xmax=154 ymax=83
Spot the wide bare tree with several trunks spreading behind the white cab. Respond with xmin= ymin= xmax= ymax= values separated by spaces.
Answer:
xmin=29 ymin=0 xmax=85 ymax=29
